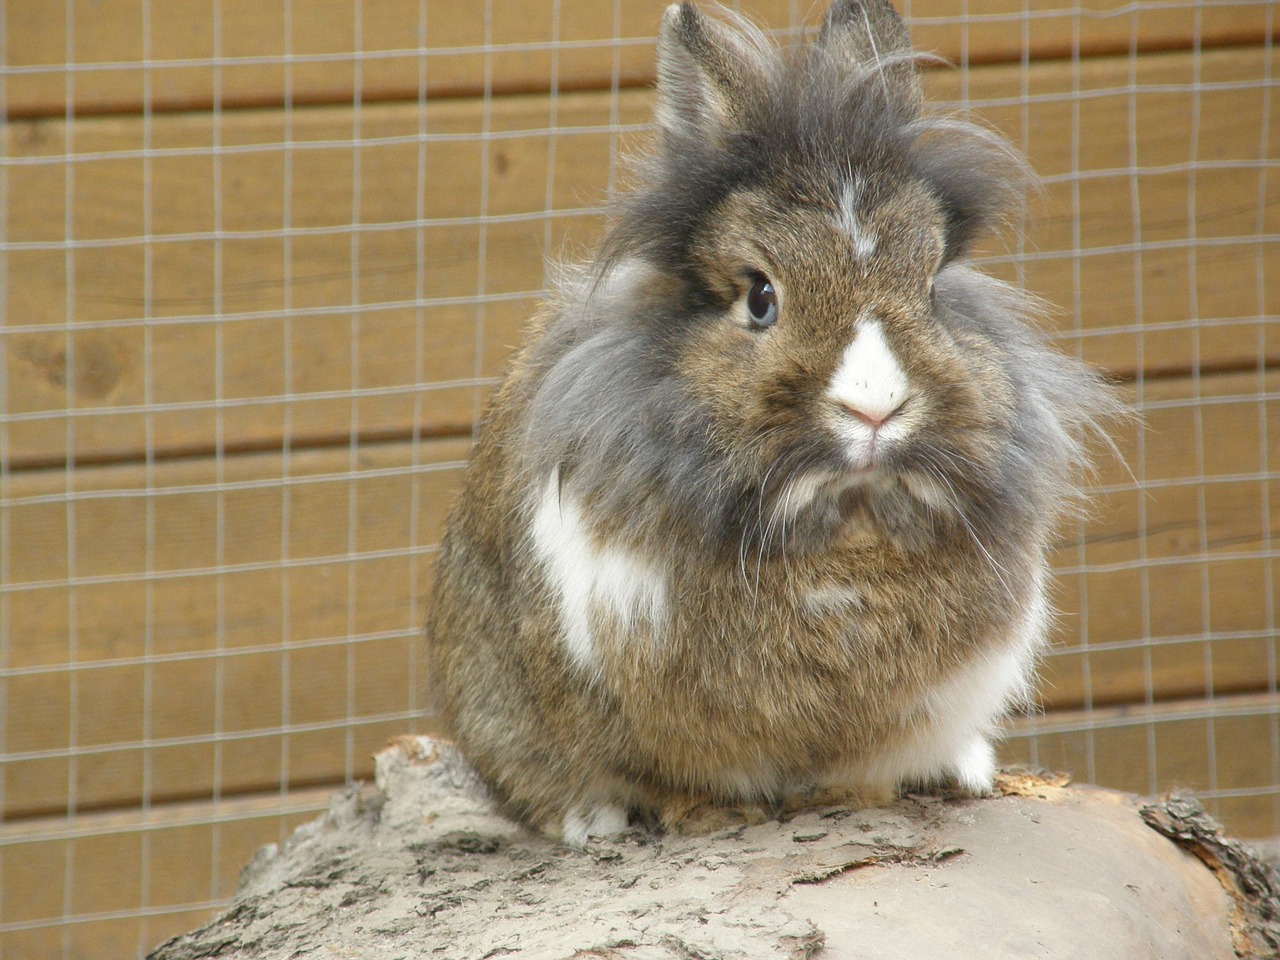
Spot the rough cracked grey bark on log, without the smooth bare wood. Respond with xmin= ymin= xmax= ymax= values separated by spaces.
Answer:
xmin=151 ymin=737 xmax=1264 ymax=960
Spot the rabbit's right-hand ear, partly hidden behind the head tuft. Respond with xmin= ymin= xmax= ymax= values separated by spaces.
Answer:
xmin=818 ymin=0 xmax=924 ymax=108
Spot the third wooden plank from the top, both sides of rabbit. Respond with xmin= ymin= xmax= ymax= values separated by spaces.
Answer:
xmin=0 ymin=371 xmax=1280 ymax=817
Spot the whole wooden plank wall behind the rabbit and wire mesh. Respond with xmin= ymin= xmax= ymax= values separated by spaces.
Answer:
xmin=0 ymin=0 xmax=1280 ymax=957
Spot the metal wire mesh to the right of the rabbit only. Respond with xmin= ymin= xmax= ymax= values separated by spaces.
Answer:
xmin=1016 ymin=5 xmax=1280 ymax=835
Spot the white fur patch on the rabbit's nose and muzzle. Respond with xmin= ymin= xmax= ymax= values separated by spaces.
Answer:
xmin=827 ymin=314 xmax=911 ymax=465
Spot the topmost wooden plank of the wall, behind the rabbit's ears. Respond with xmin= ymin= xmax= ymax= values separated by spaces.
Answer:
xmin=4 ymin=0 xmax=1267 ymax=116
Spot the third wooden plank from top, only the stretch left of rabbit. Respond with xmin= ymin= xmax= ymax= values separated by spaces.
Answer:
xmin=0 ymin=440 xmax=468 ymax=817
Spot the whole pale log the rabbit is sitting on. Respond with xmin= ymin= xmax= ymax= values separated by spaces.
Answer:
xmin=151 ymin=737 xmax=1280 ymax=960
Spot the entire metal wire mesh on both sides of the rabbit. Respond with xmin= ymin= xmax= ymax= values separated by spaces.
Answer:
xmin=0 ymin=0 xmax=1280 ymax=956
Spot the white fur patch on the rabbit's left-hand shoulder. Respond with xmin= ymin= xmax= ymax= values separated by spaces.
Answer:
xmin=532 ymin=471 xmax=667 ymax=672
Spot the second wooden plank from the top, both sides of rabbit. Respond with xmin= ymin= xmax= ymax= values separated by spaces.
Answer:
xmin=4 ymin=50 xmax=1280 ymax=466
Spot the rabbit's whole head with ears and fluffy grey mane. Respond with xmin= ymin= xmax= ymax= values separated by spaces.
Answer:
xmin=522 ymin=0 xmax=1106 ymax=563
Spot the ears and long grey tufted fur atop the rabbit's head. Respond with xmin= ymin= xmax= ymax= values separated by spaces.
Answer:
xmin=599 ymin=3 xmax=1034 ymax=277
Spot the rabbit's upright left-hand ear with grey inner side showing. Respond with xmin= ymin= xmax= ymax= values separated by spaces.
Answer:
xmin=657 ymin=3 xmax=768 ymax=140
